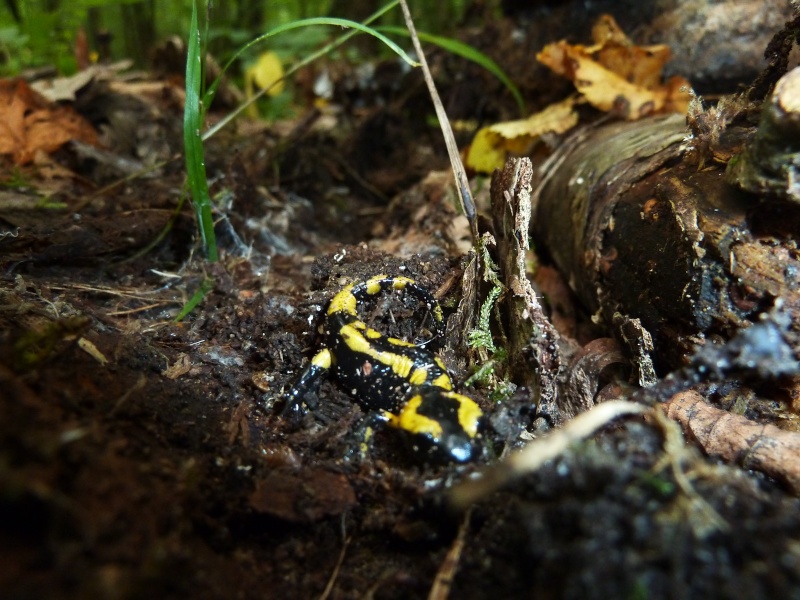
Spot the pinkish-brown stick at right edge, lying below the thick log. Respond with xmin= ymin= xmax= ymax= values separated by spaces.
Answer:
xmin=664 ymin=390 xmax=800 ymax=494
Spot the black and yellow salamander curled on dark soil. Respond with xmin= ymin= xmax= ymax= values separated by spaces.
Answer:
xmin=284 ymin=275 xmax=483 ymax=462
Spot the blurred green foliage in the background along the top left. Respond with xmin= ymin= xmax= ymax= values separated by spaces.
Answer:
xmin=0 ymin=0 xmax=476 ymax=75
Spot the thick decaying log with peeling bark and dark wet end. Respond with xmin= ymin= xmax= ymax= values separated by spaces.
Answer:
xmin=533 ymin=107 xmax=800 ymax=368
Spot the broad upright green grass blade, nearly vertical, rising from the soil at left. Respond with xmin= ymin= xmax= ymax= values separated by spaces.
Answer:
xmin=183 ymin=2 xmax=219 ymax=262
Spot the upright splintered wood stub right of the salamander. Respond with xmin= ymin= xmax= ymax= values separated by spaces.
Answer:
xmin=491 ymin=158 xmax=560 ymax=423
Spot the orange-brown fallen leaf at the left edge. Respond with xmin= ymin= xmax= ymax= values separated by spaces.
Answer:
xmin=0 ymin=79 xmax=97 ymax=165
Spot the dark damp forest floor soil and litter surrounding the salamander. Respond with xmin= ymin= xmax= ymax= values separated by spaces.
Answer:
xmin=0 ymin=8 xmax=800 ymax=599
